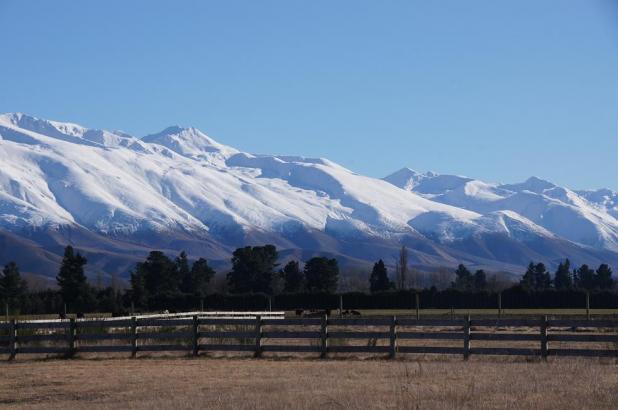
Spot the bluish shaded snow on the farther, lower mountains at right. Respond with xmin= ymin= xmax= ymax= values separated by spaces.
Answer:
xmin=385 ymin=168 xmax=618 ymax=251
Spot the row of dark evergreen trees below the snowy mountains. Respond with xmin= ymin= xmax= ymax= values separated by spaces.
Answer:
xmin=0 ymin=245 xmax=615 ymax=313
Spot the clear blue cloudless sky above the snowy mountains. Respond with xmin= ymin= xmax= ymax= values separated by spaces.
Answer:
xmin=0 ymin=0 xmax=618 ymax=190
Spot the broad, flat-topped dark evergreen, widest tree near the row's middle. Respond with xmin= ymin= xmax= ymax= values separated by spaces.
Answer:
xmin=227 ymin=245 xmax=278 ymax=294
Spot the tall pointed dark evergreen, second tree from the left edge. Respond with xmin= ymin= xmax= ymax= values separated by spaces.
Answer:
xmin=56 ymin=245 xmax=94 ymax=312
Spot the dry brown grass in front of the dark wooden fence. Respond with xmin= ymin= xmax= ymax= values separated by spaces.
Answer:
xmin=0 ymin=358 xmax=618 ymax=409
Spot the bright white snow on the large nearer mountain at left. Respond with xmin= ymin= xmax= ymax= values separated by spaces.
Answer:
xmin=0 ymin=114 xmax=479 ymax=243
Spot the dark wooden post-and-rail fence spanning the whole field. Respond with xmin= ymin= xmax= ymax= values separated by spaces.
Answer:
xmin=0 ymin=315 xmax=618 ymax=359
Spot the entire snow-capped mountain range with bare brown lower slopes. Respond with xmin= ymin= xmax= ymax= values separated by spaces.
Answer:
xmin=0 ymin=114 xmax=618 ymax=274
